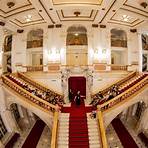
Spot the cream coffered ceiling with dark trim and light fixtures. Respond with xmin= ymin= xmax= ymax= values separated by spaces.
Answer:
xmin=0 ymin=0 xmax=148 ymax=28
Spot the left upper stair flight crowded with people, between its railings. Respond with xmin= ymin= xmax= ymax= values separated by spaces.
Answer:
xmin=7 ymin=74 xmax=64 ymax=106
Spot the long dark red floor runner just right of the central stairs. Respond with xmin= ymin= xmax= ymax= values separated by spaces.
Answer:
xmin=112 ymin=118 xmax=138 ymax=148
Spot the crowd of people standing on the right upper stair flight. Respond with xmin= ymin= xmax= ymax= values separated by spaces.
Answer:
xmin=90 ymin=85 xmax=120 ymax=107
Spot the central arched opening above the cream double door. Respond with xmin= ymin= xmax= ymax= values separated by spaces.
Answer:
xmin=66 ymin=25 xmax=88 ymax=46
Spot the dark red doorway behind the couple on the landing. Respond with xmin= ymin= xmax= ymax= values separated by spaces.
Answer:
xmin=68 ymin=77 xmax=86 ymax=96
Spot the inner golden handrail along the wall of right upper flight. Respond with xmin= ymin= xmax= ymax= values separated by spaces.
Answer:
xmin=92 ymin=71 xmax=137 ymax=96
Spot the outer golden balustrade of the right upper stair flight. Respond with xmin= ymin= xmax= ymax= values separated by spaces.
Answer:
xmin=98 ymin=76 xmax=148 ymax=111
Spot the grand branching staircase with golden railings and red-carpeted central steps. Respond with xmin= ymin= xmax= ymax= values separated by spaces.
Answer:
xmin=2 ymin=72 xmax=148 ymax=148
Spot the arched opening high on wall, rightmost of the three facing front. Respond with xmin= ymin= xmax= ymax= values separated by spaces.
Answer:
xmin=111 ymin=29 xmax=127 ymax=47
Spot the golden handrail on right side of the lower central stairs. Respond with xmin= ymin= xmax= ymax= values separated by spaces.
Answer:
xmin=97 ymin=108 xmax=107 ymax=148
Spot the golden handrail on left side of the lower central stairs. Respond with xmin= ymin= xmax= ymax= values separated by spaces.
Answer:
xmin=51 ymin=112 xmax=59 ymax=148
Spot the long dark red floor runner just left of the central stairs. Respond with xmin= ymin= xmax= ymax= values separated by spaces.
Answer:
xmin=22 ymin=120 xmax=45 ymax=148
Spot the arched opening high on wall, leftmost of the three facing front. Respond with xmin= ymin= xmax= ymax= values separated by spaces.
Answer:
xmin=27 ymin=29 xmax=43 ymax=48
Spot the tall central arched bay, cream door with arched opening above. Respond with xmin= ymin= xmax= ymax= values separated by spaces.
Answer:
xmin=66 ymin=25 xmax=88 ymax=66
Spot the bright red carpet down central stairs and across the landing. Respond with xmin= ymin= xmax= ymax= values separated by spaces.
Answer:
xmin=62 ymin=97 xmax=92 ymax=148
